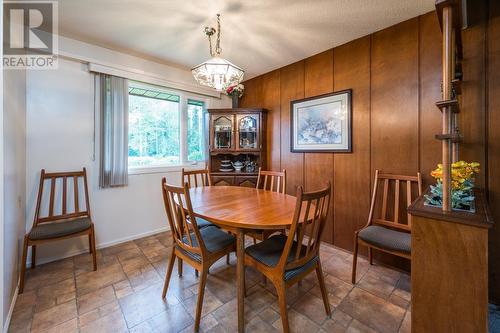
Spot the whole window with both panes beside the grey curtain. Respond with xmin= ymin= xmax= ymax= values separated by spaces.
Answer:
xmin=128 ymin=82 xmax=209 ymax=170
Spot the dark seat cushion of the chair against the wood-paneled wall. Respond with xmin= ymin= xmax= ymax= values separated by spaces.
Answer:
xmin=358 ymin=225 xmax=411 ymax=254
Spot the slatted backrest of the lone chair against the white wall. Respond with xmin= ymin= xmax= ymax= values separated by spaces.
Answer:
xmin=33 ymin=168 xmax=90 ymax=225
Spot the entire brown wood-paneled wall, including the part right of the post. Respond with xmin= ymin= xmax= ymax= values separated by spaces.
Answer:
xmin=241 ymin=12 xmax=500 ymax=282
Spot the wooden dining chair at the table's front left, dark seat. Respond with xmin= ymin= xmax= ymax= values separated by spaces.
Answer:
xmin=162 ymin=178 xmax=236 ymax=332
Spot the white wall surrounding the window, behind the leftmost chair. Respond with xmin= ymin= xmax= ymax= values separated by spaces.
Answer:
xmin=26 ymin=38 xmax=229 ymax=263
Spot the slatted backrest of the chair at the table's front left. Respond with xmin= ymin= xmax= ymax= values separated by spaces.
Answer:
xmin=161 ymin=177 xmax=207 ymax=256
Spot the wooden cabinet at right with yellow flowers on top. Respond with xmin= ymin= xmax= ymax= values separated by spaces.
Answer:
xmin=408 ymin=191 xmax=493 ymax=333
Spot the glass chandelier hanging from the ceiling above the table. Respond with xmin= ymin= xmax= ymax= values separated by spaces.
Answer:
xmin=191 ymin=14 xmax=245 ymax=91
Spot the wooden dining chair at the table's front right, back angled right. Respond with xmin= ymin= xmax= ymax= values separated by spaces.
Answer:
xmin=245 ymin=182 xmax=331 ymax=332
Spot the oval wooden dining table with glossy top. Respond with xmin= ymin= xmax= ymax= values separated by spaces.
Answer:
xmin=186 ymin=186 xmax=296 ymax=332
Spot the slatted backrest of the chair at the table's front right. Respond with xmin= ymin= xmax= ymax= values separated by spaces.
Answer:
xmin=278 ymin=182 xmax=331 ymax=270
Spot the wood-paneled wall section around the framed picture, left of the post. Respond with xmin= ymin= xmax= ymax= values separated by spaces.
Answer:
xmin=241 ymin=13 xmax=441 ymax=250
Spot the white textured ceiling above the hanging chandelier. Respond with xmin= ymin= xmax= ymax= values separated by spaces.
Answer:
xmin=59 ymin=0 xmax=434 ymax=78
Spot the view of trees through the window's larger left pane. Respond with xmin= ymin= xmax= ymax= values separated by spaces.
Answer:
xmin=128 ymin=95 xmax=181 ymax=167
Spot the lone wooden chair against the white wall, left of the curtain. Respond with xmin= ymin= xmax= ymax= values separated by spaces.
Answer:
xmin=19 ymin=168 xmax=97 ymax=294
